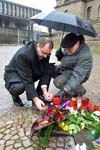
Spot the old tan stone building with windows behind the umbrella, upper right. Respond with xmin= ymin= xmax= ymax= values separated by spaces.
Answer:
xmin=55 ymin=0 xmax=100 ymax=47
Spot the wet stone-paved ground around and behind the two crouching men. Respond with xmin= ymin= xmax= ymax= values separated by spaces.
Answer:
xmin=0 ymin=46 xmax=100 ymax=150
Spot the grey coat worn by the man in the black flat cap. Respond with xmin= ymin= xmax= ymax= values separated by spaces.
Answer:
xmin=59 ymin=40 xmax=93 ymax=90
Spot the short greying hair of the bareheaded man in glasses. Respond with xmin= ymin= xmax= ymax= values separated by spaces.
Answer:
xmin=36 ymin=37 xmax=53 ymax=49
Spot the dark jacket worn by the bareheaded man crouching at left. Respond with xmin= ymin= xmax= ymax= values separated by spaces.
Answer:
xmin=4 ymin=42 xmax=50 ymax=99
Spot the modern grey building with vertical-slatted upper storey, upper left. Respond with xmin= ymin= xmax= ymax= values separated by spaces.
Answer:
xmin=0 ymin=0 xmax=41 ymax=44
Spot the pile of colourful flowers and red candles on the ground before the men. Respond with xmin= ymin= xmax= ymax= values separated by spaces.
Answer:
xmin=31 ymin=97 xmax=100 ymax=150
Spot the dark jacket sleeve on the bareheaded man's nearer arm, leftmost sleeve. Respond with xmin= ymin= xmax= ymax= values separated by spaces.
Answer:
xmin=16 ymin=55 xmax=37 ymax=100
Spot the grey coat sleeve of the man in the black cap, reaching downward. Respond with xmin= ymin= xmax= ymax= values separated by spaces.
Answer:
xmin=64 ymin=53 xmax=93 ymax=90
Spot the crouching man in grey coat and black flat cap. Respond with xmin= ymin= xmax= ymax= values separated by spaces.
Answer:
xmin=54 ymin=33 xmax=93 ymax=96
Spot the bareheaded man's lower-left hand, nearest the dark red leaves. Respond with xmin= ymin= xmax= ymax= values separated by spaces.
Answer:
xmin=32 ymin=97 xmax=46 ymax=110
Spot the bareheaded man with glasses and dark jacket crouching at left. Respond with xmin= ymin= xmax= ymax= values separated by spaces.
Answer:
xmin=4 ymin=37 xmax=54 ymax=110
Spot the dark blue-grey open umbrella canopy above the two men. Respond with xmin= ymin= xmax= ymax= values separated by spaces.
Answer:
xmin=31 ymin=11 xmax=97 ymax=37
